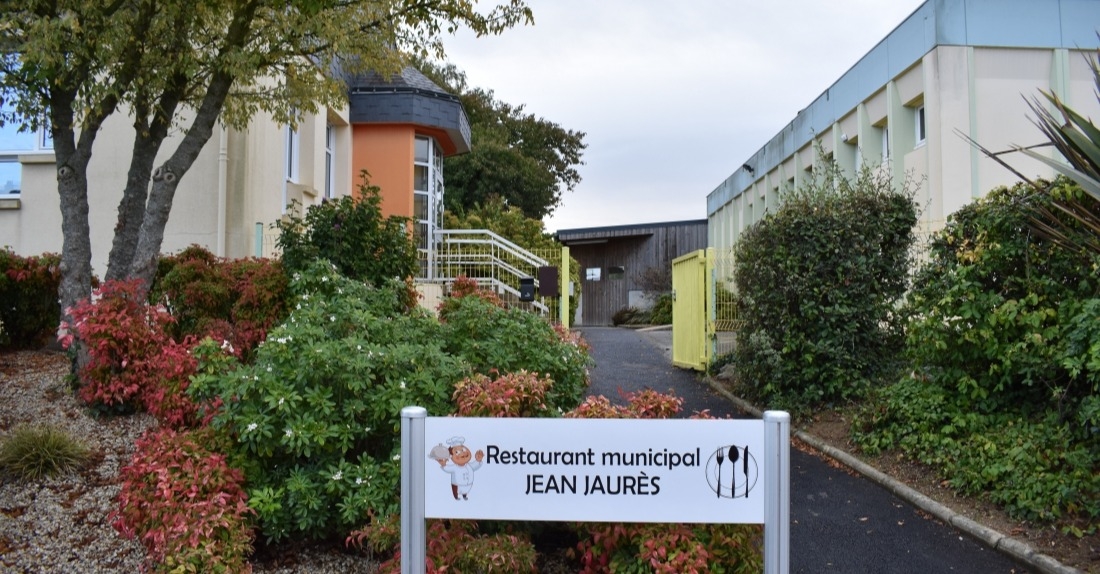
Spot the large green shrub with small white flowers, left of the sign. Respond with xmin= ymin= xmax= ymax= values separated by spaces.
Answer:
xmin=188 ymin=262 xmax=470 ymax=541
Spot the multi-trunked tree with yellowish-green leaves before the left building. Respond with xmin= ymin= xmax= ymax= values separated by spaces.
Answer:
xmin=0 ymin=0 xmax=531 ymax=329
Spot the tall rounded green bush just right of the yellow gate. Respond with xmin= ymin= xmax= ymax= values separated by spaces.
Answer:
xmin=734 ymin=159 xmax=917 ymax=408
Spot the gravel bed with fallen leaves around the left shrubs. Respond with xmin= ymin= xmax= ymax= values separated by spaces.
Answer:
xmin=0 ymin=352 xmax=377 ymax=574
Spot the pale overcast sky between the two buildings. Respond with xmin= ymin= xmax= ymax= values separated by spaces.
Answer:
xmin=444 ymin=0 xmax=923 ymax=232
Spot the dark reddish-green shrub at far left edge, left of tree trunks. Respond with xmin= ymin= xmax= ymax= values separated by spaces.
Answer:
xmin=0 ymin=247 xmax=62 ymax=349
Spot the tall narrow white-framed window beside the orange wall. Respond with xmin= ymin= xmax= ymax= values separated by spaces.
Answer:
xmin=413 ymin=135 xmax=443 ymax=277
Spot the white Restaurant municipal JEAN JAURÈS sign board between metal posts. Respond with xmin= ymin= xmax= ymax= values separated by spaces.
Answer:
xmin=424 ymin=417 xmax=768 ymax=523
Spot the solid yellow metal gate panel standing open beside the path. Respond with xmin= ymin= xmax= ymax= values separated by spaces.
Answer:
xmin=672 ymin=249 xmax=714 ymax=371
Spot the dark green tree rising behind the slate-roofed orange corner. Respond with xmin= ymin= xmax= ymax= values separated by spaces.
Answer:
xmin=420 ymin=63 xmax=587 ymax=220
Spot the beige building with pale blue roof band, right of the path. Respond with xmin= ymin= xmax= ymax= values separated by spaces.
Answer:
xmin=707 ymin=0 xmax=1100 ymax=254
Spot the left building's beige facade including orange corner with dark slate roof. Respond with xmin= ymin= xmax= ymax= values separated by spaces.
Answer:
xmin=0 ymin=68 xmax=470 ymax=276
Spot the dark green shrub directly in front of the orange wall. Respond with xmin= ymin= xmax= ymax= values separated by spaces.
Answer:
xmin=276 ymin=174 xmax=419 ymax=294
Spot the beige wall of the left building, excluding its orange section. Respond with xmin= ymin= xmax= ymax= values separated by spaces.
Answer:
xmin=0 ymin=101 xmax=352 ymax=270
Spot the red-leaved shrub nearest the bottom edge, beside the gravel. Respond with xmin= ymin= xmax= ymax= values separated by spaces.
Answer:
xmin=111 ymin=428 xmax=253 ymax=573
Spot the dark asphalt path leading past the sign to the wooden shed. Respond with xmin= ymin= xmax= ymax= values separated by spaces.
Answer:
xmin=578 ymin=327 xmax=1032 ymax=574
